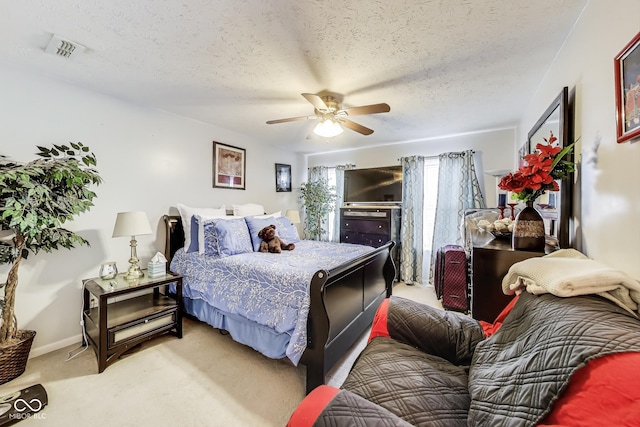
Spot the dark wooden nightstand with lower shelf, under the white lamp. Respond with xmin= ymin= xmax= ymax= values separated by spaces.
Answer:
xmin=82 ymin=271 xmax=182 ymax=372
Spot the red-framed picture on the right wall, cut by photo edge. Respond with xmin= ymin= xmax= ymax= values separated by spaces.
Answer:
xmin=614 ymin=33 xmax=640 ymax=142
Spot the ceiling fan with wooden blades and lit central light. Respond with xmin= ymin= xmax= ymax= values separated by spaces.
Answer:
xmin=267 ymin=93 xmax=391 ymax=138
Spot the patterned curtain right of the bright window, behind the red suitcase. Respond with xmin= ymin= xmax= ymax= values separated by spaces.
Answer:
xmin=429 ymin=150 xmax=486 ymax=284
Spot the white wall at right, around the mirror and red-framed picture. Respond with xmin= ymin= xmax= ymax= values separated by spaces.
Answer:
xmin=519 ymin=0 xmax=640 ymax=279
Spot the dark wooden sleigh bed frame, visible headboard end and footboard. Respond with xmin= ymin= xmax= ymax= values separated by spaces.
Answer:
xmin=164 ymin=215 xmax=396 ymax=393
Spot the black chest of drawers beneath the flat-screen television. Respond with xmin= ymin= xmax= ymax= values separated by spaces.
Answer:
xmin=340 ymin=206 xmax=401 ymax=278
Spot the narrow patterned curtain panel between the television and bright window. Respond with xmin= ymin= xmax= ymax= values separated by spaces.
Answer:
xmin=396 ymin=156 xmax=424 ymax=285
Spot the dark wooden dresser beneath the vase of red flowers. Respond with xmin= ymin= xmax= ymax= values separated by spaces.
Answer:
xmin=469 ymin=232 xmax=554 ymax=322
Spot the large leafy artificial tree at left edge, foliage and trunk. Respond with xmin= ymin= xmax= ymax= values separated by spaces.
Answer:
xmin=0 ymin=142 xmax=102 ymax=347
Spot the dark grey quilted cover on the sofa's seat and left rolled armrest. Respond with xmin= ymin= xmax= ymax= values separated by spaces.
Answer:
xmin=340 ymin=296 xmax=483 ymax=427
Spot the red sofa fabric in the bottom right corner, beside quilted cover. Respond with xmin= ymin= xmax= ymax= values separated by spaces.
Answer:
xmin=540 ymin=352 xmax=640 ymax=427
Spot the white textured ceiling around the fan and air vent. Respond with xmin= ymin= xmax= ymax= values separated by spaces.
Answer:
xmin=0 ymin=0 xmax=587 ymax=152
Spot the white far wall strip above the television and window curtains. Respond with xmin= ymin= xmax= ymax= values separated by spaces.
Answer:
xmin=307 ymin=127 xmax=524 ymax=207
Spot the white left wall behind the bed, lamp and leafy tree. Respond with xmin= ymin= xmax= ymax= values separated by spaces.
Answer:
xmin=0 ymin=64 xmax=306 ymax=357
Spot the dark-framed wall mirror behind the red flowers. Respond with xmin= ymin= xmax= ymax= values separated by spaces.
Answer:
xmin=527 ymin=87 xmax=573 ymax=248
